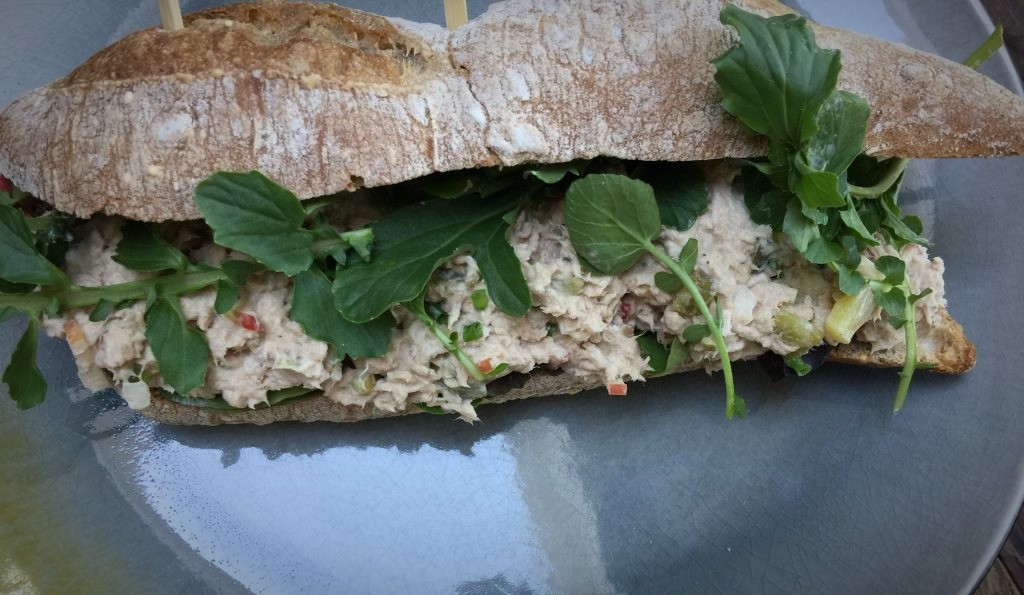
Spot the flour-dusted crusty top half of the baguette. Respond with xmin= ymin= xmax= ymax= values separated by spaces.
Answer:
xmin=0 ymin=0 xmax=1024 ymax=220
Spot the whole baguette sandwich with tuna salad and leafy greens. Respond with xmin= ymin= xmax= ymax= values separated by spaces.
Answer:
xmin=0 ymin=0 xmax=1024 ymax=425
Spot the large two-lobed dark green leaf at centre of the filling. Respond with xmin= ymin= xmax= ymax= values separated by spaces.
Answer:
xmin=334 ymin=188 xmax=532 ymax=323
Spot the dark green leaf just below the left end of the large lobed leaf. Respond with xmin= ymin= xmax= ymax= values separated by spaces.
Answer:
xmin=292 ymin=268 xmax=395 ymax=357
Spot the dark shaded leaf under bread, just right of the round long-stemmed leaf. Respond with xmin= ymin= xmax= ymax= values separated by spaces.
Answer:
xmin=638 ymin=162 xmax=708 ymax=231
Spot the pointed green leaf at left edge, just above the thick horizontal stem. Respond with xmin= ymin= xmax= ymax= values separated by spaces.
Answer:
xmin=0 ymin=205 xmax=69 ymax=285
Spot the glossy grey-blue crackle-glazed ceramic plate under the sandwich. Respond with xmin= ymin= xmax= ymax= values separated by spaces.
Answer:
xmin=0 ymin=0 xmax=1024 ymax=593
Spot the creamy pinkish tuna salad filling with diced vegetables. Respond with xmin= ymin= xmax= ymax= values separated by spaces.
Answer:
xmin=37 ymin=160 xmax=945 ymax=421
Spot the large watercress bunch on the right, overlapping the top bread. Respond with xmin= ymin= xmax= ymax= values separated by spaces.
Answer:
xmin=715 ymin=4 xmax=929 ymax=409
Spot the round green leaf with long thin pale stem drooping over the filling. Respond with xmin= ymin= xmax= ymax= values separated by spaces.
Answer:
xmin=565 ymin=174 xmax=746 ymax=419
